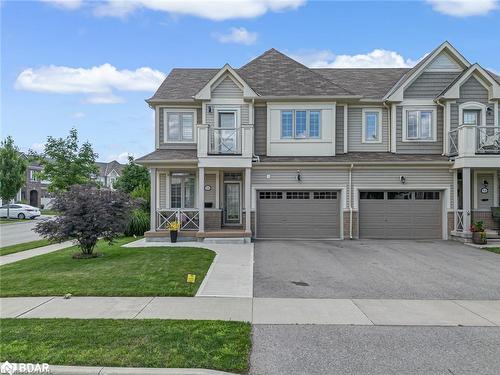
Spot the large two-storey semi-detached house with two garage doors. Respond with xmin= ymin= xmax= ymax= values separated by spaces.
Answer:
xmin=136 ymin=42 xmax=500 ymax=240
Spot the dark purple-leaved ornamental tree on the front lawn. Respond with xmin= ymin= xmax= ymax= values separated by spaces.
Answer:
xmin=35 ymin=185 xmax=134 ymax=257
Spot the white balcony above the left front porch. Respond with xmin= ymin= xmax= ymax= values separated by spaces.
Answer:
xmin=197 ymin=124 xmax=253 ymax=167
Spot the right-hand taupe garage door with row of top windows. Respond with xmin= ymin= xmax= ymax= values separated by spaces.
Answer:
xmin=359 ymin=191 xmax=442 ymax=239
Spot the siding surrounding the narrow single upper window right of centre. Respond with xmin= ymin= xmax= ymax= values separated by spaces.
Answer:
xmin=347 ymin=107 xmax=389 ymax=152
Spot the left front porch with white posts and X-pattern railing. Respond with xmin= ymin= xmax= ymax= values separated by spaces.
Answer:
xmin=145 ymin=166 xmax=252 ymax=242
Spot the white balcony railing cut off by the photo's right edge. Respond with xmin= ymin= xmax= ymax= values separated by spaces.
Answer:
xmin=448 ymin=125 xmax=500 ymax=156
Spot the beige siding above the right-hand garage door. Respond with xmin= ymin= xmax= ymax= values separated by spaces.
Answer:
xmin=352 ymin=167 xmax=453 ymax=208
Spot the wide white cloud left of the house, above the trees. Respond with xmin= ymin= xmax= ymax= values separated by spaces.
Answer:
xmin=15 ymin=64 xmax=165 ymax=103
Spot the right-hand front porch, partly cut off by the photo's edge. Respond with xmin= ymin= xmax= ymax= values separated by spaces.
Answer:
xmin=452 ymin=168 xmax=500 ymax=241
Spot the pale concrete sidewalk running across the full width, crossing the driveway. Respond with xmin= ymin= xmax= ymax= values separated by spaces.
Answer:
xmin=0 ymin=297 xmax=500 ymax=327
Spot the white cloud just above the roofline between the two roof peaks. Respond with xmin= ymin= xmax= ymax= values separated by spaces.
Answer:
xmin=290 ymin=49 xmax=417 ymax=68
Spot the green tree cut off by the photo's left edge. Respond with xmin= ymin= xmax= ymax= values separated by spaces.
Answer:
xmin=0 ymin=136 xmax=27 ymax=219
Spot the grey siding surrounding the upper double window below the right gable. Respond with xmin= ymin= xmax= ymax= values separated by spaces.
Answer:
xmin=396 ymin=106 xmax=443 ymax=154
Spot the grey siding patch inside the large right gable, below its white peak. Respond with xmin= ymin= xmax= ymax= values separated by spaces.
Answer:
xmin=404 ymin=72 xmax=460 ymax=99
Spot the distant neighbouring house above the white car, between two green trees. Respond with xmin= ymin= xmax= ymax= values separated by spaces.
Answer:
xmin=17 ymin=161 xmax=52 ymax=208
